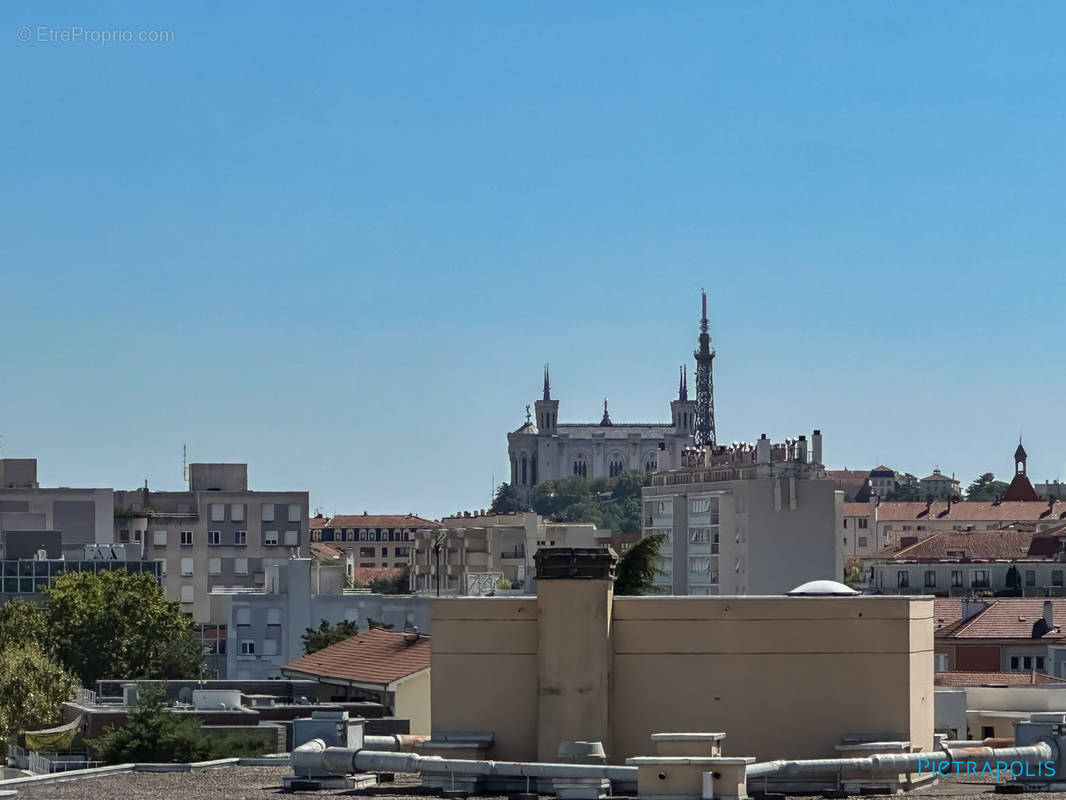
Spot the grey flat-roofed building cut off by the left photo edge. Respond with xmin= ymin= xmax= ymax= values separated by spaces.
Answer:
xmin=0 ymin=459 xmax=114 ymax=559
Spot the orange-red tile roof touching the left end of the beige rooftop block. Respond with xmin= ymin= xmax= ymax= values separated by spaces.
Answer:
xmin=281 ymin=628 xmax=430 ymax=687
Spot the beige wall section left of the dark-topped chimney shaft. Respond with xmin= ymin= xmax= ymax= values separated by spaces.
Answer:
xmin=430 ymin=597 xmax=537 ymax=761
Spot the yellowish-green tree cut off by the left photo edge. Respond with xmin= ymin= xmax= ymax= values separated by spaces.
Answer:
xmin=0 ymin=644 xmax=78 ymax=739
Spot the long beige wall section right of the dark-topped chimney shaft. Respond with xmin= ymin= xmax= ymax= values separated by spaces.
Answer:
xmin=611 ymin=597 xmax=933 ymax=761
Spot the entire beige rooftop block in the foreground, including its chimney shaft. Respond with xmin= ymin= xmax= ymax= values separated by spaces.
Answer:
xmin=431 ymin=593 xmax=933 ymax=763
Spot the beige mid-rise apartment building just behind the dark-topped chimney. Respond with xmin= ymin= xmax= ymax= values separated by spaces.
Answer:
xmin=411 ymin=512 xmax=615 ymax=594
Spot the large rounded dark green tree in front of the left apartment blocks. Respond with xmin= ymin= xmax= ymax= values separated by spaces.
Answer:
xmin=45 ymin=570 xmax=204 ymax=686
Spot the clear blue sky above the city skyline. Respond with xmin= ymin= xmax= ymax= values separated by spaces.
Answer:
xmin=0 ymin=0 xmax=1066 ymax=516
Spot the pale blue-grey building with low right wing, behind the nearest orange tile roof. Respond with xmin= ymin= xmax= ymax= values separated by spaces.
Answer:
xmin=209 ymin=558 xmax=430 ymax=681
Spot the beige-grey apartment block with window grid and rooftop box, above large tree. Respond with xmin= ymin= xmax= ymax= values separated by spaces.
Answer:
xmin=113 ymin=464 xmax=308 ymax=622
